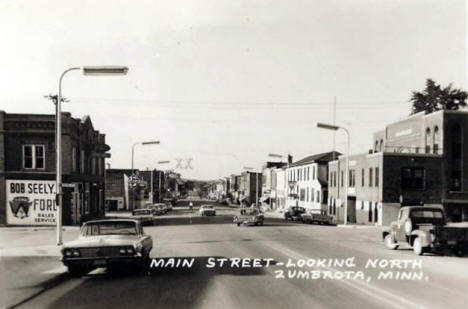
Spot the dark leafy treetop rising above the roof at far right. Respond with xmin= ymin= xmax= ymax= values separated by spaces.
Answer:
xmin=410 ymin=78 xmax=468 ymax=114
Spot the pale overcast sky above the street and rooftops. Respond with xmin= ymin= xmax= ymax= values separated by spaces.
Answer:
xmin=0 ymin=0 xmax=467 ymax=179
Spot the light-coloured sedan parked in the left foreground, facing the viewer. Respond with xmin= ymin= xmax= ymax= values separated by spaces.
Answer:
xmin=61 ymin=219 xmax=153 ymax=276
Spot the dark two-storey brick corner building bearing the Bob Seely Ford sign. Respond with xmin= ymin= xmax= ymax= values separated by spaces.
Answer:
xmin=0 ymin=111 xmax=110 ymax=225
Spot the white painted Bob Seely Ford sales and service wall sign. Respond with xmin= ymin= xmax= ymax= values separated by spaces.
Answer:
xmin=6 ymin=180 xmax=57 ymax=225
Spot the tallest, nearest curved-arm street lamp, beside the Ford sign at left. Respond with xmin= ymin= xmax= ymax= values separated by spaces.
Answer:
xmin=55 ymin=66 xmax=128 ymax=246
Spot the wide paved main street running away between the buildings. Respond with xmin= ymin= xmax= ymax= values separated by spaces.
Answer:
xmin=0 ymin=202 xmax=468 ymax=309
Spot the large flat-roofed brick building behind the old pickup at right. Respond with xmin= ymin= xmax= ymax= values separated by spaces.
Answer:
xmin=328 ymin=111 xmax=468 ymax=225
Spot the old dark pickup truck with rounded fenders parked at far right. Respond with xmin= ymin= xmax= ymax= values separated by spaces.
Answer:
xmin=382 ymin=206 xmax=468 ymax=256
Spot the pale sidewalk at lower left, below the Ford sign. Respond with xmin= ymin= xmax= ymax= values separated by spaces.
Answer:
xmin=0 ymin=226 xmax=79 ymax=308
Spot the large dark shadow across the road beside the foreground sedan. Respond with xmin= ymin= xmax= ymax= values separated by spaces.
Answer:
xmin=47 ymin=256 xmax=273 ymax=309
